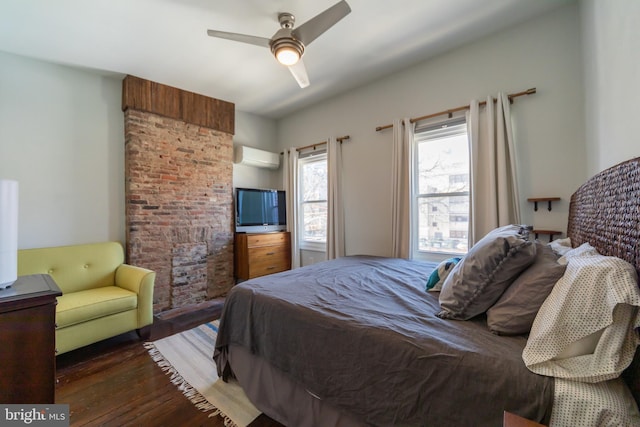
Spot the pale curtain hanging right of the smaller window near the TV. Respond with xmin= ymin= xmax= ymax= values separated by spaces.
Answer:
xmin=326 ymin=138 xmax=345 ymax=259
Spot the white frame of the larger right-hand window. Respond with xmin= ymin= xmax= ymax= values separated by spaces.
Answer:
xmin=411 ymin=117 xmax=472 ymax=261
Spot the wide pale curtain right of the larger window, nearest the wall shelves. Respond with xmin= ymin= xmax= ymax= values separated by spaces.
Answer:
xmin=467 ymin=92 xmax=520 ymax=244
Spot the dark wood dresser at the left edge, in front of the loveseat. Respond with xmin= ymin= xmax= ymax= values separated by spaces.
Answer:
xmin=0 ymin=274 xmax=62 ymax=404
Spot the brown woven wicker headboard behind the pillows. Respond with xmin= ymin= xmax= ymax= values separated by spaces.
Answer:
xmin=567 ymin=157 xmax=640 ymax=406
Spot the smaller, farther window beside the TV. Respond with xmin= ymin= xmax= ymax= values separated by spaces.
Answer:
xmin=298 ymin=153 xmax=327 ymax=251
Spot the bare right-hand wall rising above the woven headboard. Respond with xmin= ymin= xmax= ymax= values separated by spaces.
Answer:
xmin=580 ymin=0 xmax=640 ymax=176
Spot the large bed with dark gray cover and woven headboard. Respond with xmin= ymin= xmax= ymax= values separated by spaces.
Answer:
xmin=214 ymin=159 xmax=640 ymax=426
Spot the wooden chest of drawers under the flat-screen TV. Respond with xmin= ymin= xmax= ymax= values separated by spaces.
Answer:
xmin=235 ymin=231 xmax=291 ymax=280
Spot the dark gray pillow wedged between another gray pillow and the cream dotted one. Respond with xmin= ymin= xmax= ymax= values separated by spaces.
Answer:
xmin=487 ymin=242 xmax=567 ymax=335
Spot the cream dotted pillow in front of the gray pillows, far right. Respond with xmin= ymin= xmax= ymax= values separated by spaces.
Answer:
xmin=522 ymin=243 xmax=640 ymax=382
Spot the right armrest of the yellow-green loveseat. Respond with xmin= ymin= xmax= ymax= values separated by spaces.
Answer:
xmin=116 ymin=264 xmax=156 ymax=328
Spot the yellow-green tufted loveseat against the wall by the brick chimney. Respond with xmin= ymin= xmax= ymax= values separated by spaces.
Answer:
xmin=18 ymin=242 xmax=155 ymax=354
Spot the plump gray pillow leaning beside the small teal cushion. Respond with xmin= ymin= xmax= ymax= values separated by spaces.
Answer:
xmin=438 ymin=225 xmax=536 ymax=320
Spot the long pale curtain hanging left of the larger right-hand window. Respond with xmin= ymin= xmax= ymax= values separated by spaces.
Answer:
xmin=391 ymin=118 xmax=415 ymax=258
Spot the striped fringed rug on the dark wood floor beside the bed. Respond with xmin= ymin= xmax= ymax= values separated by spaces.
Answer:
xmin=144 ymin=320 xmax=260 ymax=427
